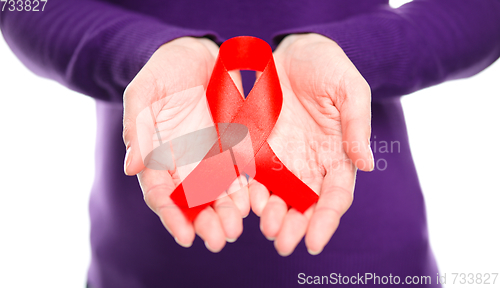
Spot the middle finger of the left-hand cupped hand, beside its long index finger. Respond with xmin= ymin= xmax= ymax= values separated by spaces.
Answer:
xmin=193 ymin=206 xmax=228 ymax=253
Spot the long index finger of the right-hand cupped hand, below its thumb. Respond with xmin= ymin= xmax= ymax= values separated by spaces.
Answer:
xmin=305 ymin=161 xmax=356 ymax=255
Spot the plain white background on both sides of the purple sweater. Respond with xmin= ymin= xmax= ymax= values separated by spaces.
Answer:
xmin=0 ymin=1 xmax=500 ymax=288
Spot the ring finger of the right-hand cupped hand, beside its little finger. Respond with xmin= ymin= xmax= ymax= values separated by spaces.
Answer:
xmin=260 ymin=195 xmax=288 ymax=241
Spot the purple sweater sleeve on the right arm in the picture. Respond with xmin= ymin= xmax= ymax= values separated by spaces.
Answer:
xmin=274 ymin=0 xmax=500 ymax=100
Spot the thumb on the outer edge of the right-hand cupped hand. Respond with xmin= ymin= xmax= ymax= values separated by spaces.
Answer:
xmin=334 ymin=67 xmax=374 ymax=171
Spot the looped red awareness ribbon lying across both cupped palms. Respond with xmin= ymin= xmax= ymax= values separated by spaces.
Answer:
xmin=170 ymin=36 xmax=318 ymax=221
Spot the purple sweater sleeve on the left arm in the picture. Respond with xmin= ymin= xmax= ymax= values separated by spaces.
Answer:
xmin=0 ymin=0 xmax=216 ymax=102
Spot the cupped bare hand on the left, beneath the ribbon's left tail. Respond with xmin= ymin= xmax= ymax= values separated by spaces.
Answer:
xmin=123 ymin=37 xmax=250 ymax=252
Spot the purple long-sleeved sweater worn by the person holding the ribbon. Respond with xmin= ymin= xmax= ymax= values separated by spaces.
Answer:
xmin=0 ymin=0 xmax=500 ymax=288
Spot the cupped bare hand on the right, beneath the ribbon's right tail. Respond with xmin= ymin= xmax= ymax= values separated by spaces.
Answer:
xmin=250 ymin=34 xmax=374 ymax=256
